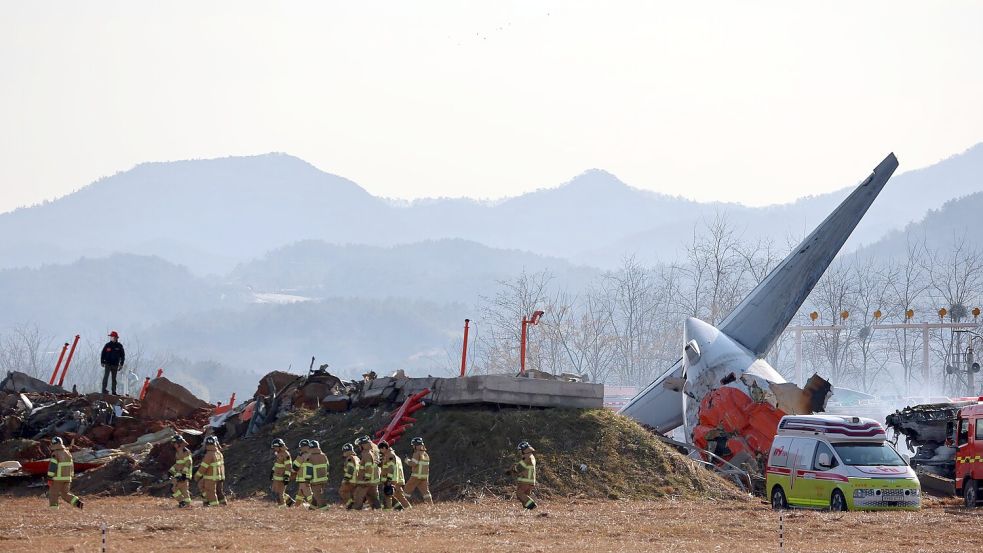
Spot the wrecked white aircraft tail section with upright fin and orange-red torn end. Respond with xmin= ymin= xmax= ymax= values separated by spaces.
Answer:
xmin=620 ymin=153 xmax=898 ymax=470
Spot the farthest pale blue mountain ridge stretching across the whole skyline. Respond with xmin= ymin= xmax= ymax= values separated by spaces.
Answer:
xmin=0 ymin=145 xmax=983 ymax=275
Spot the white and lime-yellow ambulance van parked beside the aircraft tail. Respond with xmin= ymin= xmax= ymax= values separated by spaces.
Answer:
xmin=765 ymin=415 xmax=921 ymax=511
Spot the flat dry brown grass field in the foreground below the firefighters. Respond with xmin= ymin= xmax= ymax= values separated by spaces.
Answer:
xmin=0 ymin=497 xmax=968 ymax=553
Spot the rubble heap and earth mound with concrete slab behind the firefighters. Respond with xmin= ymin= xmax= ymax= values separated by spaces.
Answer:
xmin=0 ymin=366 xmax=734 ymax=497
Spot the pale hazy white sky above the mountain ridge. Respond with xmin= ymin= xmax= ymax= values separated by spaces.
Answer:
xmin=0 ymin=0 xmax=983 ymax=211
